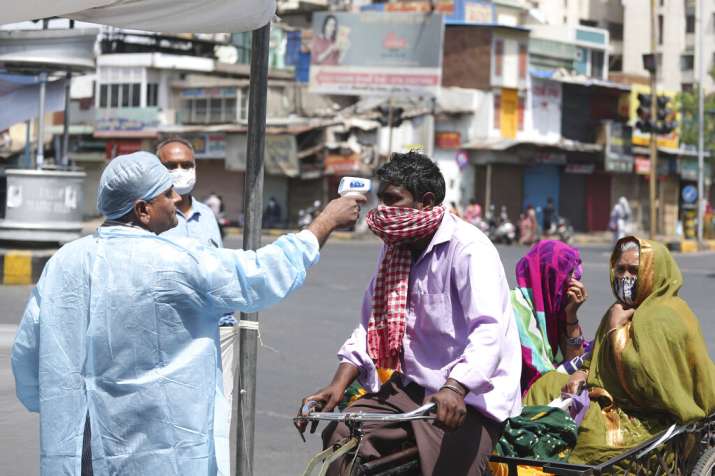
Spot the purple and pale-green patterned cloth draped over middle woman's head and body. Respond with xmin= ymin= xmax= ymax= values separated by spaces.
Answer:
xmin=514 ymin=240 xmax=583 ymax=391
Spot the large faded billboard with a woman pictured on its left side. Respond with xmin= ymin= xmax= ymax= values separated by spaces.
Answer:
xmin=310 ymin=12 xmax=444 ymax=95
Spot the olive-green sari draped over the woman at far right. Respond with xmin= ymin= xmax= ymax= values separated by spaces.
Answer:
xmin=524 ymin=238 xmax=715 ymax=464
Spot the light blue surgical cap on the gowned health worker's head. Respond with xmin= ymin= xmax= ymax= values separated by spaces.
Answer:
xmin=97 ymin=152 xmax=173 ymax=220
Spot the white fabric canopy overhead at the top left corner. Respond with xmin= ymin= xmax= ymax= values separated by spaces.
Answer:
xmin=0 ymin=0 xmax=276 ymax=33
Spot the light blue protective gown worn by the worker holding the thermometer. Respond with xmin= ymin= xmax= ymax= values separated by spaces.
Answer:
xmin=12 ymin=226 xmax=319 ymax=476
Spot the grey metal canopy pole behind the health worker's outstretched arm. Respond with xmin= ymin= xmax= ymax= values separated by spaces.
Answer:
xmin=232 ymin=23 xmax=271 ymax=476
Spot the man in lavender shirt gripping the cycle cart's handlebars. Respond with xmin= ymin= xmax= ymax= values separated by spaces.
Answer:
xmin=299 ymin=153 xmax=521 ymax=476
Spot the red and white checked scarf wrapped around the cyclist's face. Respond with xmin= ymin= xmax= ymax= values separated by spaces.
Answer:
xmin=367 ymin=205 xmax=445 ymax=371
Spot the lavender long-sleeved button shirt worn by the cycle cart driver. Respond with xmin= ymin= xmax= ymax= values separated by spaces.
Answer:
xmin=338 ymin=213 xmax=521 ymax=421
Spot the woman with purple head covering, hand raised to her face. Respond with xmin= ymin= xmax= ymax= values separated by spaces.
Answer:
xmin=511 ymin=240 xmax=588 ymax=393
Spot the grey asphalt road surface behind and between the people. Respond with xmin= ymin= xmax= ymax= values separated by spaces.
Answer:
xmin=0 ymin=240 xmax=715 ymax=476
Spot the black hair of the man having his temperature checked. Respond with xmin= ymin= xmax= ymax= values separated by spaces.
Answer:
xmin=376 ymin=152 xmax=445 ymax=205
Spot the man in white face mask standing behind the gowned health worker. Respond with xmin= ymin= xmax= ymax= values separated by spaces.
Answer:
xmin=156 ymin=137 xmax=223 ymax=248
